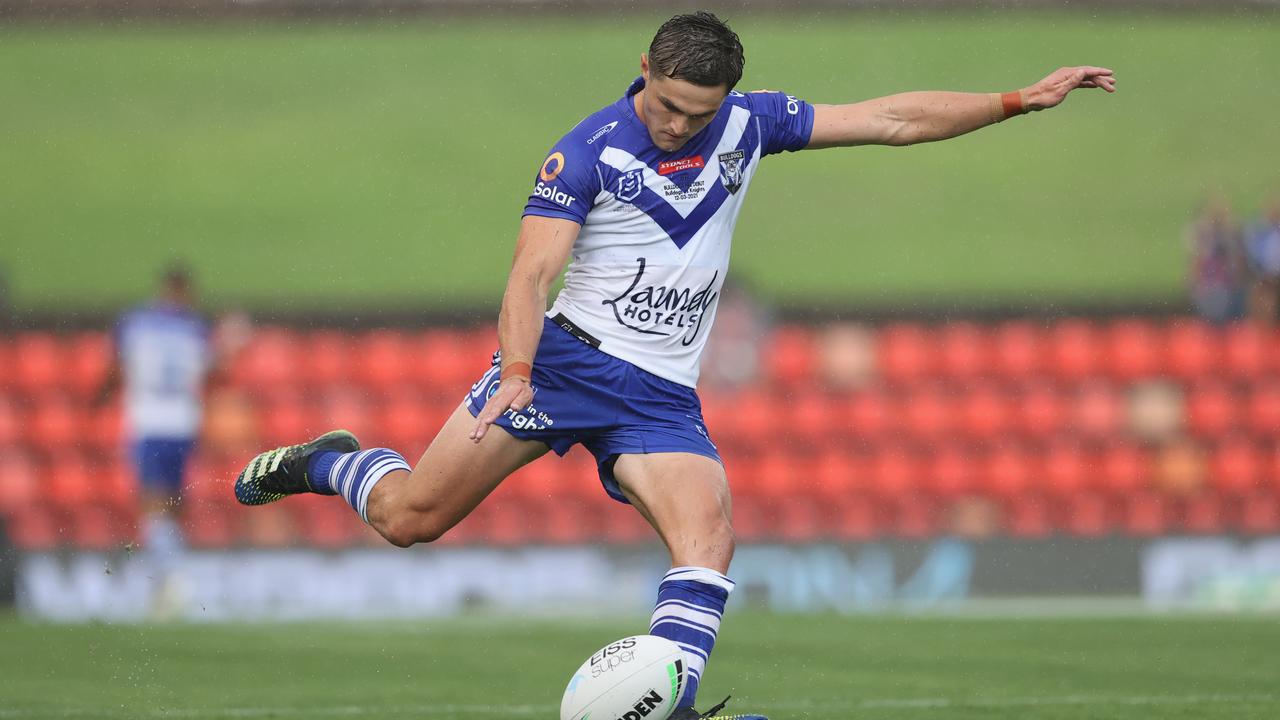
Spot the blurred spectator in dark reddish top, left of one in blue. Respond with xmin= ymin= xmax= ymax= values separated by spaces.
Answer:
xmin=1187 ymin=197 xmax=1245 ymax=324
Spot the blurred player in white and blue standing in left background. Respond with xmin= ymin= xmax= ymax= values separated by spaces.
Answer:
xmin=99 ymin=264 xmax=247 ymax=619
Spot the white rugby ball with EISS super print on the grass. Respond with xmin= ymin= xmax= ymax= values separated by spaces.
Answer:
xmin=561 ymin=635 xmax=689 ymax=720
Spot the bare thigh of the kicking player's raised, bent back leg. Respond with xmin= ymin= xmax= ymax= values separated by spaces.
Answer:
xmin=398 ymin=397 xmax=548 ymax=527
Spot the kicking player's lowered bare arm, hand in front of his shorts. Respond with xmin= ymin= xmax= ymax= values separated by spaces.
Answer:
xmin=471 ymin=215 xmax=582 ymax=442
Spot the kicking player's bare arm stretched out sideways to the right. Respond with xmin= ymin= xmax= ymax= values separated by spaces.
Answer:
xmin=805 ymin=65 xmax=1116 ymax=150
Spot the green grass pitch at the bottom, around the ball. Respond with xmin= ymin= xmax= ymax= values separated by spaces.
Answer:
xmin=0 ymin=614 xmax=1280 ymax=720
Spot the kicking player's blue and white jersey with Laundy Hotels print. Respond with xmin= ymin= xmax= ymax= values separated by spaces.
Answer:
xmin=525 ymin=78 xmax=813 ymax=387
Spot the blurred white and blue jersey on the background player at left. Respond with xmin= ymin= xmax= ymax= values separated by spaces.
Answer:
xmin=115 ymin=304 xmax=211 ymax=439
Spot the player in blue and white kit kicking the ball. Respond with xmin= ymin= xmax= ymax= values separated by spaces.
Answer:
xmin=236 ymin=13 xmax=1115 ymax=720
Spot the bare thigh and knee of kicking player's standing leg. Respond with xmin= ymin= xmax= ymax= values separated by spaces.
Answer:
xmin=613 ymin=452 xmax=733 ymax=573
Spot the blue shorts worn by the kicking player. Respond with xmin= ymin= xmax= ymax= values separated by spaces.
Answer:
xmin=467 ymin=318 xmax=721 ymax=502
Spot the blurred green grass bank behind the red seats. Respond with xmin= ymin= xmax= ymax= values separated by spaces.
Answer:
xmin=0 ymin=9 xmax=1280 ymax=313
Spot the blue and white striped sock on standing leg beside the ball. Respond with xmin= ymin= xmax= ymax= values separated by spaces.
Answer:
xmin=649 ymin=568 xmax=733 ymax=707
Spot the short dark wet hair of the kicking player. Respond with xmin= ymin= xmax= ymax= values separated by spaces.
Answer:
xmin=649 ymin=10 xmax=746 ymax=90
